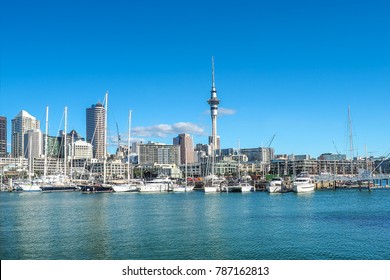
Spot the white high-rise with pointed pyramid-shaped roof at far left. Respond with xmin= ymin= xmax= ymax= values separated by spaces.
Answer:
xmin=11 ymin=110 xmax=40 ymax=158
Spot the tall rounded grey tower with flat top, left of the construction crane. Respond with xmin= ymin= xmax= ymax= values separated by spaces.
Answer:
xmin=86 ymin=102 xmax=106 ymax=159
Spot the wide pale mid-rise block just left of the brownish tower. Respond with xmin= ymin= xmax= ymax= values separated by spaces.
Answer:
xmin=138 ymin=142 xmax=180 ymax=165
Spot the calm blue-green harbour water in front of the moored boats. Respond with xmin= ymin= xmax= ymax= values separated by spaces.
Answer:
xmin=0 ymin=190 xmax=390 ymax=260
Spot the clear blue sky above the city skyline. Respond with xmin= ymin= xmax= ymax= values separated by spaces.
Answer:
xmin=0 ymin=0 xmax=390 ymax=157
